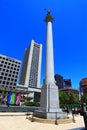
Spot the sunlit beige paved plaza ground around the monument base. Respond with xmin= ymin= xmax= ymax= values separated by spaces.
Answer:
xmin=0 ymin=112 xmax=84 ymax=130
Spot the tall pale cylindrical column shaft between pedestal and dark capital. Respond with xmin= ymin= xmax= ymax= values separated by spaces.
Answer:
xmin=45 ymin=21 xmax=54 ymax=85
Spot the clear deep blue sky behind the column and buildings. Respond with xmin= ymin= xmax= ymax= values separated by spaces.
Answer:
xmin=0 ymin=0 xmax=87 ymax=88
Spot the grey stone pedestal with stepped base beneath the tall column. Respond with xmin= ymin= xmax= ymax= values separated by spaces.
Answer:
xmin=34 ymin=84 xmax=67 ymax=119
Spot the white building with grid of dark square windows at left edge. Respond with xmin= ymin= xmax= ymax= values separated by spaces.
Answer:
xmin=0 ymin=55 xmax=21 ymax=88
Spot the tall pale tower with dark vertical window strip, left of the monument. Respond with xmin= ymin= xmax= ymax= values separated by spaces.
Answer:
xmin=19 ymin=40 xmax=42 ymax=88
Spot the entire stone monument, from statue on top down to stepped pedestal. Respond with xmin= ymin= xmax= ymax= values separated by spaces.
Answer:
xmin=34 ymin=11 xmax=66 ymax=119
